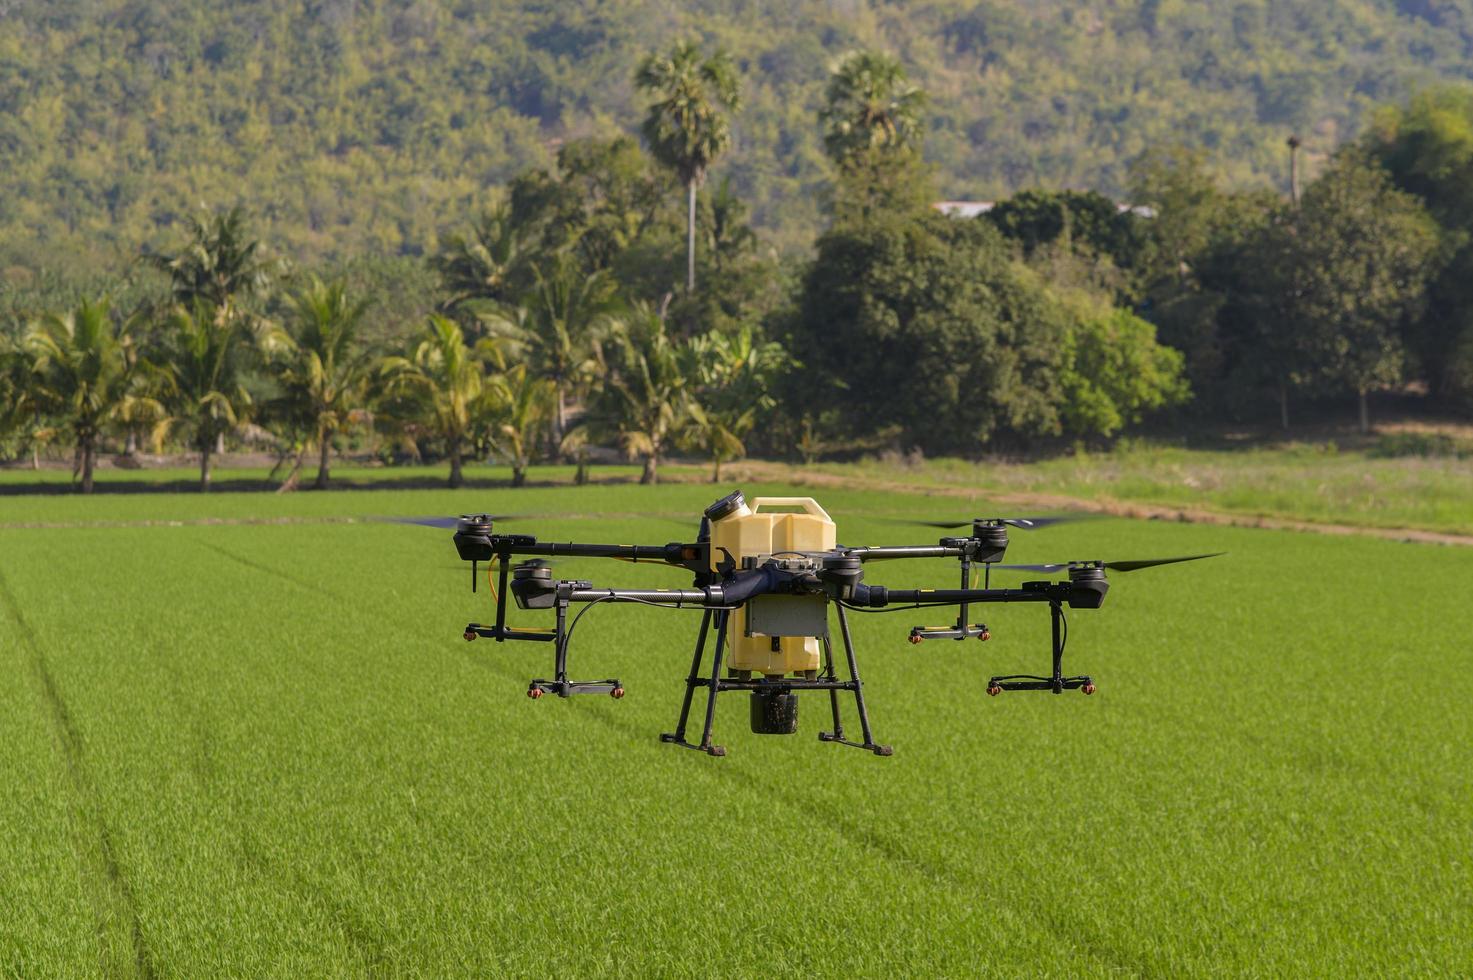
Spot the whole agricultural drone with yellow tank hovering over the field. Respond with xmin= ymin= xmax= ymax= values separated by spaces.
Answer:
xmin=411 ymin=491 xmax=1214 ymax=756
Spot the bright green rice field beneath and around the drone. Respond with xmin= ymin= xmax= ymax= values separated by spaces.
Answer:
xmin=0 ymin=485 xmax=1473 ymax=977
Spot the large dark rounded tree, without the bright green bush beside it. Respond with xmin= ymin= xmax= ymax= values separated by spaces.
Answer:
xmin=782 ymin=212 xmax=1069 ymax=452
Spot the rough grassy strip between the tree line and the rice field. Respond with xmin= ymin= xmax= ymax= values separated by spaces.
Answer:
xmin=11 ymin=444 xmax=1473 ymax=535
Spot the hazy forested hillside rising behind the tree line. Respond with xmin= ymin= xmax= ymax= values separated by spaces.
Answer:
xmin=0 ymin=0 xmax=1473 ymax=267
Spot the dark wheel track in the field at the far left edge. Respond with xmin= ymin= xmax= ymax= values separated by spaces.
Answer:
xmin=0 ymin=572 xmax=158 ymax=979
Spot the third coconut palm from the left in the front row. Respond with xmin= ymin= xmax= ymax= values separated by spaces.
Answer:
xmin=268 ymin=277 xmax=376 ymax=489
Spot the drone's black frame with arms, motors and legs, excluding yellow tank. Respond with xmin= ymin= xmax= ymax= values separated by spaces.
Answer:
xmin=441 ymin=498 xmax=1209 ymax=756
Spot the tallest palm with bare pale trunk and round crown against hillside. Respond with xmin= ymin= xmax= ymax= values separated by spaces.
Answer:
xmin=635 ymin=41 xmax=741 ymax=292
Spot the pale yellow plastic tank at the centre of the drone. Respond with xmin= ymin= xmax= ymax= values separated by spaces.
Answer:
xmin=711 ymin=497 xmax=835 ymax=676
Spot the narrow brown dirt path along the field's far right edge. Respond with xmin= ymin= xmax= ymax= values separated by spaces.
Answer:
xmin=728 ymin=461 xmax=1473 ymax=547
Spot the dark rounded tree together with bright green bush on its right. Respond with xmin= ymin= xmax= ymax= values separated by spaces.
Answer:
xmin=785 ymin=214 xmax=1186 ymax=452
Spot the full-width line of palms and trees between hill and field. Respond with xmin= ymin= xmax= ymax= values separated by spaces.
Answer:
xmin=0 ymin=41 xmax=1473 ymax=491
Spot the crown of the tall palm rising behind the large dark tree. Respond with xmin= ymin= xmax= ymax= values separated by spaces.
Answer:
xmin=819 ymin=50 xmax=927 ymax=165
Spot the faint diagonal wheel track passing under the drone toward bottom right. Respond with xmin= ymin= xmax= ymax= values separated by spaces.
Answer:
xmin=210 ymin=542 xmax=1150 ymax=976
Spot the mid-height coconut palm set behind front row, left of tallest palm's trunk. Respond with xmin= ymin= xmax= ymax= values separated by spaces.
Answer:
xmin=485 ymin=253 xmax=623 ymax=447
